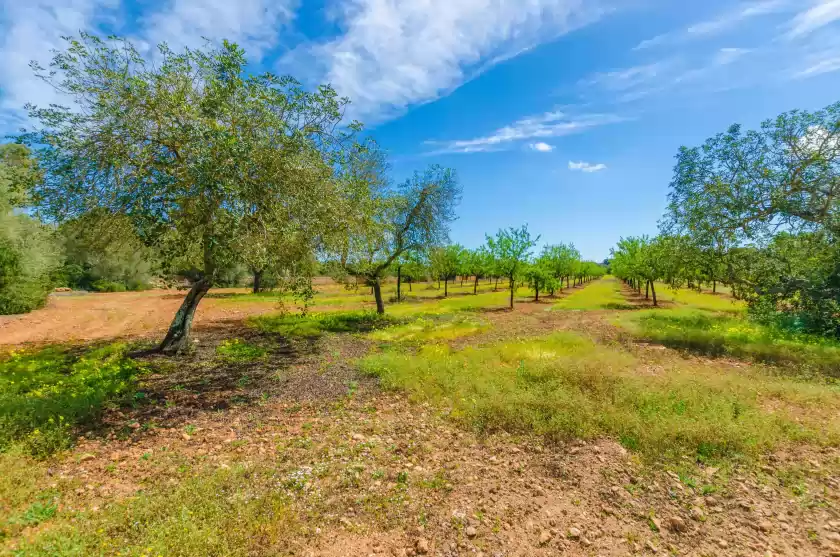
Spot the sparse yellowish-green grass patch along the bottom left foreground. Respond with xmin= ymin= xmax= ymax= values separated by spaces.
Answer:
xmin=15 ymin=467 xmax=301 ymax=557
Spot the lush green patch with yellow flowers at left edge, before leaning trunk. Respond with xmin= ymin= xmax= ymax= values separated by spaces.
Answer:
xmin=0 ymin=344 xmax=141 ymax=457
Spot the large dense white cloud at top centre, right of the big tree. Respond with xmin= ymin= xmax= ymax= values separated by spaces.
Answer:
xmin=285 ymin=0 xmax=603 ymax=121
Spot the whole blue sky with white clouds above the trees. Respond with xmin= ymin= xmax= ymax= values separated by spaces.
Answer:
xmin=0 ymin=0 xmax=840 ymax=259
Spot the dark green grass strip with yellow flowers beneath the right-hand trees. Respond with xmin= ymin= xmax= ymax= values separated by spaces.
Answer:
xmin=620 ymin=310 xmax=840 ymax=377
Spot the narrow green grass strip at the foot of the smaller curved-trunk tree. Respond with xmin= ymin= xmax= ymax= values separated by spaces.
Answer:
xmin=247 ymin=311 xmax=397 ymax=337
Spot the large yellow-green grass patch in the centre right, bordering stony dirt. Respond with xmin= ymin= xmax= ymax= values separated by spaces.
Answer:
xmin=361 ymin=333 xmax=840 ymax=460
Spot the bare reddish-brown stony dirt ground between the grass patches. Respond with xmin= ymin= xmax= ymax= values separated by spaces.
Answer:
xmin=0 ymin=284 xmax=840 ymax=557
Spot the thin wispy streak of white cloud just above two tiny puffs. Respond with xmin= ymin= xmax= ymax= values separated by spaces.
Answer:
xmin=426 ymin=111 xmax=626 ymax=154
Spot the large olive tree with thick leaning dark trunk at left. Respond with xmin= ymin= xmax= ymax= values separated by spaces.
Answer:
xmin=23 ymin=34 xmax=357 ymax=352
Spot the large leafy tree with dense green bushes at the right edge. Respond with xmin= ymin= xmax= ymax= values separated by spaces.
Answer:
xmin=612 ymin=99 xmax=840 ymax=338
